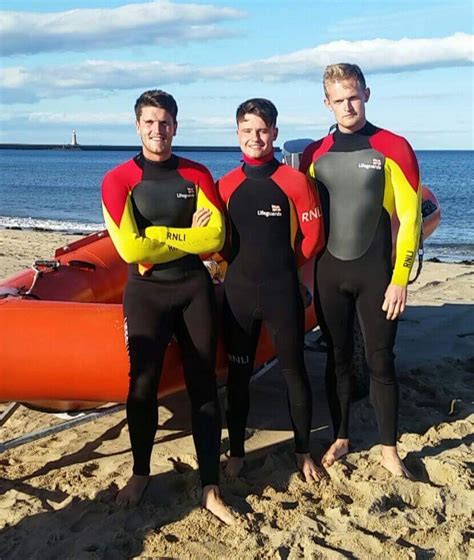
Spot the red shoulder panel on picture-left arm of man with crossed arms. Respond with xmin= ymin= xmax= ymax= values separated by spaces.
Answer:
xmin=102 ymin=159 xmax=143 ymax=226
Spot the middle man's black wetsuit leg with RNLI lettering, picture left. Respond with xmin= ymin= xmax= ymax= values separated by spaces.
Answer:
xmin=223 ymin=282 xmax=261 ymax=457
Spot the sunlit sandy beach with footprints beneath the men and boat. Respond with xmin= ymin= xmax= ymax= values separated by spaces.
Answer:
xmin=0 ymin=230 xmax=474 ymax=560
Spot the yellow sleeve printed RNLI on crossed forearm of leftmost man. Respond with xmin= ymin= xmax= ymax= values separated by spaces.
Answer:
xmin=145 ymin=179 xmax=225 ymax=255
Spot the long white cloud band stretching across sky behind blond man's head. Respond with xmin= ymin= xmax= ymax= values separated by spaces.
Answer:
xmin=0 ymin=33 xmax=474 ymax=102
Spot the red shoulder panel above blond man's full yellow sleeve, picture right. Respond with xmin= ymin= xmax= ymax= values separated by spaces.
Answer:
xmin=370 ymin=129 xmax=420 ymax=192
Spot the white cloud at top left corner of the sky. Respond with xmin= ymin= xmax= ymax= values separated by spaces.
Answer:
xmin=0 ymin=0 xmax=243 ymax=56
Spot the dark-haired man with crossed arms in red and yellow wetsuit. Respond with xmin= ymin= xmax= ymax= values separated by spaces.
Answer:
xmin=102 ymin=90 xmax=233 ymax=523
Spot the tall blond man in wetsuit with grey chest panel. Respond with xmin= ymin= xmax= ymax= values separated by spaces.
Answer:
xmin=300 ymin=63 xmax=421 ymax=478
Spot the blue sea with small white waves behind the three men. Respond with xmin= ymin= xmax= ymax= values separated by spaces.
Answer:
xmin=0 ymin=149 xmax=474 ymax=261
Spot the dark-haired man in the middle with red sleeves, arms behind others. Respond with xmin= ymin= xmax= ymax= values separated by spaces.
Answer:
xmin=218 ymin=99 xmax=323 ymax=481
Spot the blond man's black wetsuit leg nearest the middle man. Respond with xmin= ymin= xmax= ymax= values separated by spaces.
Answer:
xmin=314 ymin=251 xmax=355 ymax=439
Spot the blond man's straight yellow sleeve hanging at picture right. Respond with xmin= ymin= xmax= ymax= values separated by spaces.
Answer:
xmin=385 ymin=141 xmax=422 ymax=286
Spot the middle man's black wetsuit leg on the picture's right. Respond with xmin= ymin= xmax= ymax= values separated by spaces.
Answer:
xmin=259 ymin=273 xmax=313 ymax=453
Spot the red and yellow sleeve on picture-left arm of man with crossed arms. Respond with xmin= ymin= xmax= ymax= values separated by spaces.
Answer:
xmin=102 ymin=172 xmax=186 ymax=264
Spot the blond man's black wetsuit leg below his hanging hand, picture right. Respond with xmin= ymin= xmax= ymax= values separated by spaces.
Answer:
xmin=356 ymin=266 xmax=398 ymax=445
